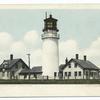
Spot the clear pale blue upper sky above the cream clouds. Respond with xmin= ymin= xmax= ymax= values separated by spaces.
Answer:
xmin=0 ymin=9 xmax=100 ymax=47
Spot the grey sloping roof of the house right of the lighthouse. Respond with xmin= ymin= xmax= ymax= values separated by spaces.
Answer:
xmin=69 ymin=58 xmax=100 ymax=70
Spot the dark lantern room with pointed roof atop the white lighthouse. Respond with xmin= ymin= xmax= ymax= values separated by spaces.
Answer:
xmin=43 ymin=14 xmax=59 ymax=32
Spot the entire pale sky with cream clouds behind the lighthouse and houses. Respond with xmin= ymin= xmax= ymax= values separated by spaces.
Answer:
xmin=0 ymin=9 xmax=100 ymax=66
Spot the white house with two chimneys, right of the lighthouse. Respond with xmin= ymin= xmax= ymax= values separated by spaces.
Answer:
xmin=59 ymin=54 xmax=100 ymax=79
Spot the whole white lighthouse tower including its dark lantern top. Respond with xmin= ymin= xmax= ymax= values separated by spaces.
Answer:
xmin=42 ymin=15 xmax=59 ymax=79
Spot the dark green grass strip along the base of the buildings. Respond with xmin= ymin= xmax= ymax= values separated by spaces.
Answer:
xmin=0 ymin=79 xmax=100 ymax=84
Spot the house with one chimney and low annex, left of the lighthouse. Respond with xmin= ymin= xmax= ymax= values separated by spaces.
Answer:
xmin=0 ymin=54 xmax=42 ymax=79
